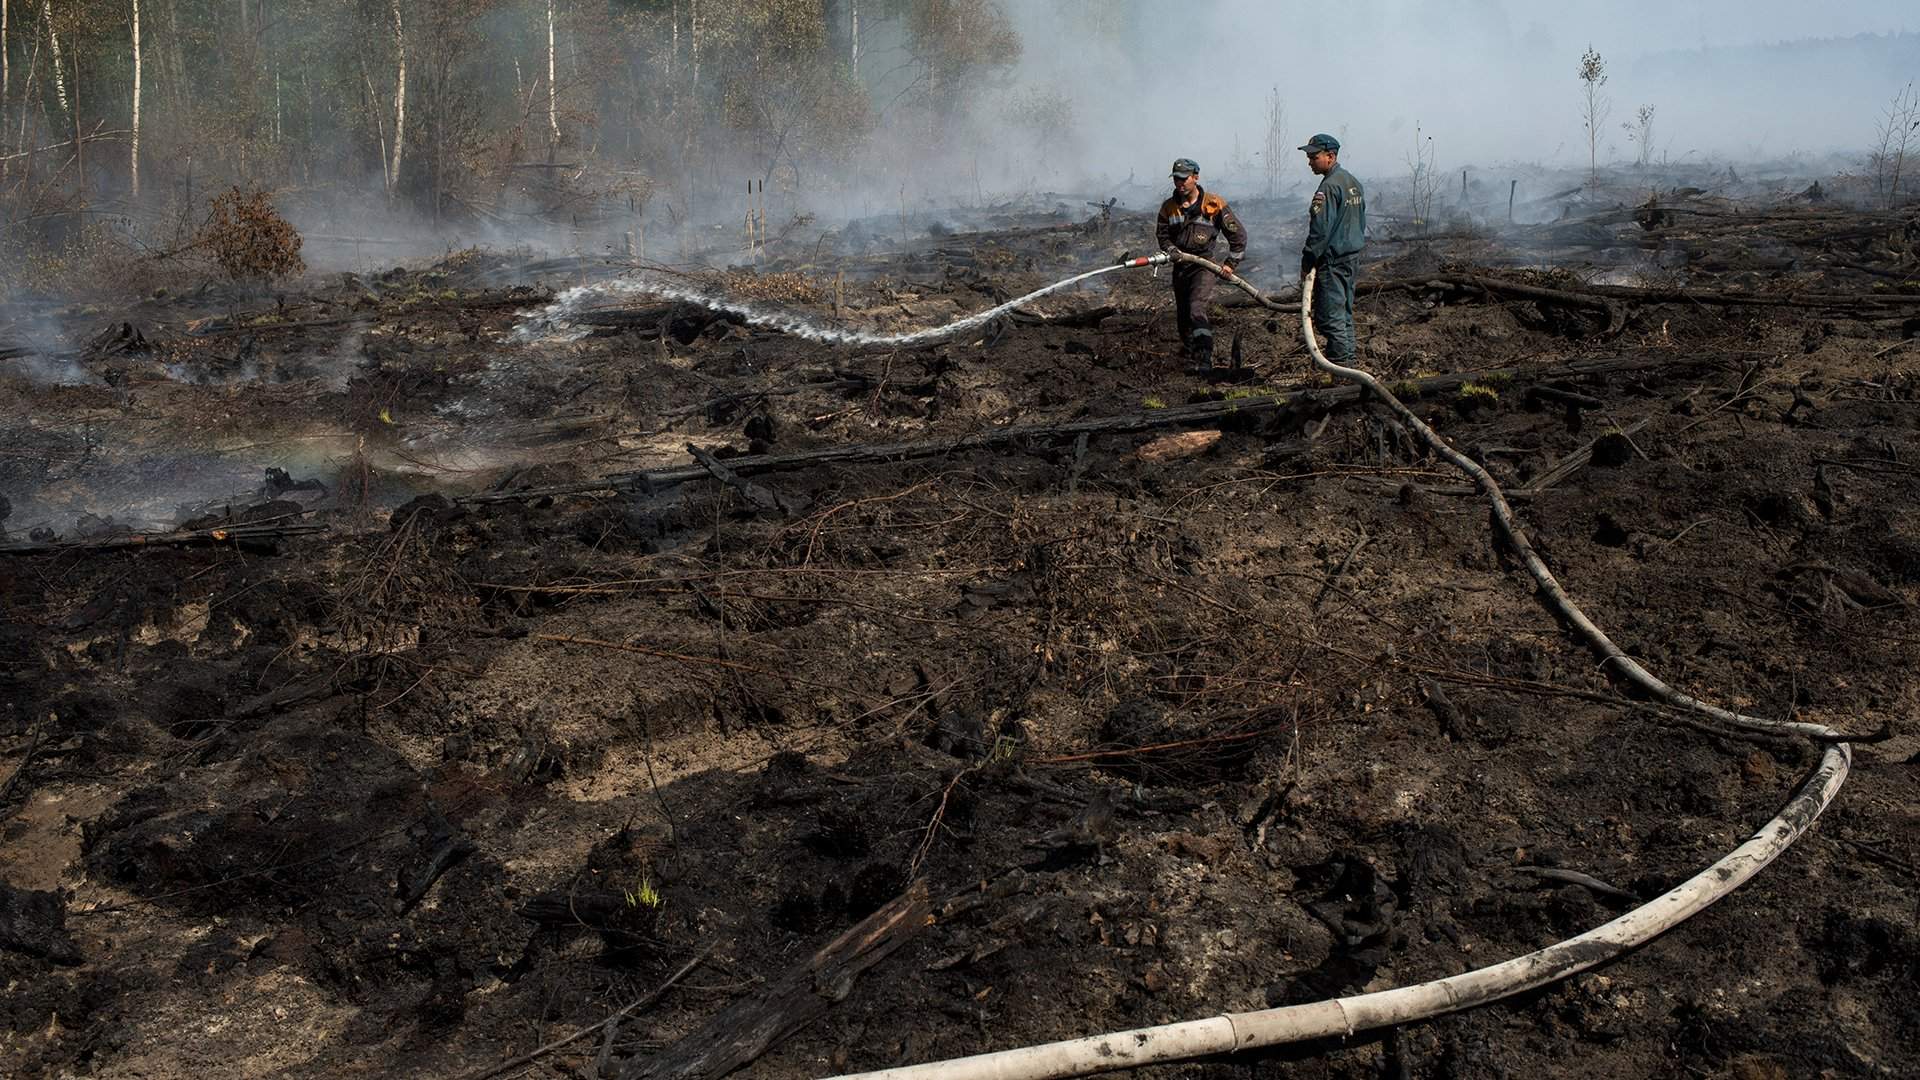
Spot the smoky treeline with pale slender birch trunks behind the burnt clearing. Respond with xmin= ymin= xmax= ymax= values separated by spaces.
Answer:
xmin=0 ymin=0 xmax=1117 ymax=286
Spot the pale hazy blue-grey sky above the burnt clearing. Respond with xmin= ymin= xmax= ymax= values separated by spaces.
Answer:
xmin=1006 ymin=0 xmax=1920 ymax=186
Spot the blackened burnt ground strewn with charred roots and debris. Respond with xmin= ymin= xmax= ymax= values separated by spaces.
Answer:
xmin=0 ymin=195 xmax=1920 ymax=1080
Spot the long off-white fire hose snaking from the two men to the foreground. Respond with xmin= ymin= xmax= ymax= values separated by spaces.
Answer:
xmin=843 ymin=252 xmax=1853 ymax=1080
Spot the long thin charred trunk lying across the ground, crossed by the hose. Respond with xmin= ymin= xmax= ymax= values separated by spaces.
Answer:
xmin=459 ymin=354 xmax=1743 ymax=503
